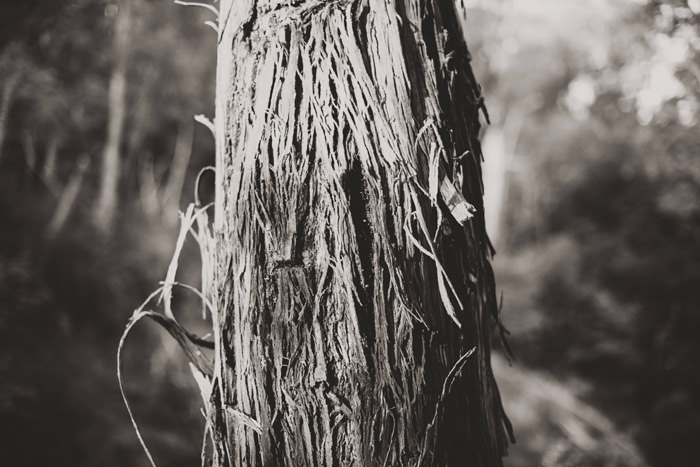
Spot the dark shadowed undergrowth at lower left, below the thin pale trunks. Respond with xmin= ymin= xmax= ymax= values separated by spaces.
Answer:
xmin=0 ymin=167 xmax=203 ymax=466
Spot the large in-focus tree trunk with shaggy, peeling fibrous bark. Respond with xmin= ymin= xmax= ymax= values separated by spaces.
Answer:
xmin=208 ymin=0 xmax=508 ymax=467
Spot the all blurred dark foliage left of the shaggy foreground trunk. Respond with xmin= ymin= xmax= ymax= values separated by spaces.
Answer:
xmin=0 ymin=0 xmax=216 ymax=466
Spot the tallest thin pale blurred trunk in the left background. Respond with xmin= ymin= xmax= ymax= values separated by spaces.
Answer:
xmin=94 ymin=0 xmax=131 ymax=232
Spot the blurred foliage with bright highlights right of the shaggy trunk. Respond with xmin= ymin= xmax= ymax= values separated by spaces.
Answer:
xmin=467 ymin=0 xmax=700 ymax=466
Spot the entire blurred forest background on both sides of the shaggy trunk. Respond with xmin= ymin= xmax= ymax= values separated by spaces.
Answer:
xmin=0 ymin=0 xmax=700 ymax=467
